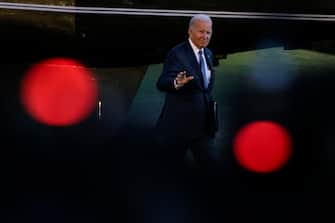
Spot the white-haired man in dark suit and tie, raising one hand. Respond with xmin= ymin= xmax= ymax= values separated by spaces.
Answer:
xmin=156 ymin=14 xmax=215 ymax=172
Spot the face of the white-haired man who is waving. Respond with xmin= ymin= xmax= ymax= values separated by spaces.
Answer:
xmin=188 ymin=20 xmax=212 ymax=49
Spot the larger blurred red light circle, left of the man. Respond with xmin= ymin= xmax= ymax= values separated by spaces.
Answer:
xmin=21 ymin=58 xmax=97 ymax=126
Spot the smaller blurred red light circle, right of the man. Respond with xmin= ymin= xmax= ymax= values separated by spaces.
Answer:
xmin=233 ymin=121 xmax=292 ymax=173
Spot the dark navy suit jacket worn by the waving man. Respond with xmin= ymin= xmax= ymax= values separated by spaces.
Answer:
xmin=157 ymin=40 xmax=215 ymax=140
